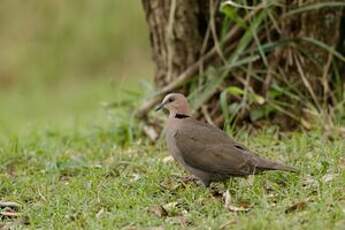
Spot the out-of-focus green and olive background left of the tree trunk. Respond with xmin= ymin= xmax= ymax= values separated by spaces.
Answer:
xmin=0 ymin=0 xmax=153 ymax=140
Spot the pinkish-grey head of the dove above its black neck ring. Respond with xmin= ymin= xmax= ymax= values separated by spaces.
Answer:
xmin=156 ymin=93 xmax=189 ymax=115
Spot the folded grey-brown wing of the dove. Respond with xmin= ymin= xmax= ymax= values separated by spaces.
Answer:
xmin=175 ymin=118 xmax=256 ymax=175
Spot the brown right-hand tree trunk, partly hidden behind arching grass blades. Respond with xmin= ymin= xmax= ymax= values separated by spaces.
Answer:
xmin=280 ymin=0 xmax=345 ymax=102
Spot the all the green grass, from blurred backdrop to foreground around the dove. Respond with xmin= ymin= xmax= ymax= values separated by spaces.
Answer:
xmin=0 ymin=0 xmax=345 ymax=229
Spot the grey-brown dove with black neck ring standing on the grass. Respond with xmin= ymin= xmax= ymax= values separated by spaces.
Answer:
xmin=155 ymin=93 xmax=297 ymax=187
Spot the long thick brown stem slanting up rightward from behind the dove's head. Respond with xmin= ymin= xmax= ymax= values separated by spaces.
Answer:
xmin=135 ymin=3 xmax=265 ymax=118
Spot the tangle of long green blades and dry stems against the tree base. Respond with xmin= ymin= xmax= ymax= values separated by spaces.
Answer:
xmin=191 ymin=1 xmax=345 ymax=129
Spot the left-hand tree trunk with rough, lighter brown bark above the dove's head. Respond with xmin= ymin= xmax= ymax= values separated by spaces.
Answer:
xmin=142 ymin=0 xmax=209 ymax=88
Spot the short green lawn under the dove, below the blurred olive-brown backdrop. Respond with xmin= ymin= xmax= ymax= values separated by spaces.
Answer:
xmin=0 ymin=81 xmax=345 ymax=229
